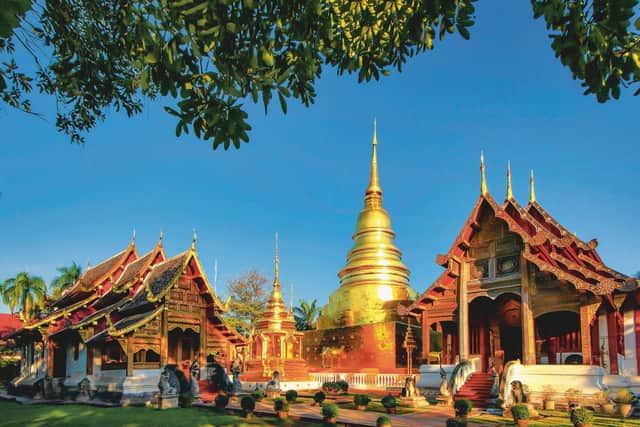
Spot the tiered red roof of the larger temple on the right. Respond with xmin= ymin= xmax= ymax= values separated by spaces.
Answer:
xmin=410 ymin=192 xmax=640 ymax=312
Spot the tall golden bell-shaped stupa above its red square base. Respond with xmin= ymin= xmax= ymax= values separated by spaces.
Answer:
xmin=318 ymin=123 xmax=416 ymax=329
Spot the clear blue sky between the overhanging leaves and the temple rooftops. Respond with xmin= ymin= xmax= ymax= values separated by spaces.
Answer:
xmin=0 ymin=1 xmax=640 ymax=309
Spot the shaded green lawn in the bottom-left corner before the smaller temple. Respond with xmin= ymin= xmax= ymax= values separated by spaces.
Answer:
xmin=0 ymin=401 xmax=319 ymax=427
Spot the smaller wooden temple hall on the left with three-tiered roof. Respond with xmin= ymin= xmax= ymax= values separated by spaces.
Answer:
xmin=12 ymin=236 xmax=245 ymax=397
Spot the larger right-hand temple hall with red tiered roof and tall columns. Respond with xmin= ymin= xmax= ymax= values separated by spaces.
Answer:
xmin=410 ymin=160 xmax=640 ymax=375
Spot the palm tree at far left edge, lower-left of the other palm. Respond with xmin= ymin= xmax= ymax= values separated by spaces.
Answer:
xmin=0 ymin=272 xmax=47 ymax=321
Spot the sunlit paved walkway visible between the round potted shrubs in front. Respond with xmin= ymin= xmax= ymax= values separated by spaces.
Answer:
xmin=198 ymin=397 xmax=490 ymax=427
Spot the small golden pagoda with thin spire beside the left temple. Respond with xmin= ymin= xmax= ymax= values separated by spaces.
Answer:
xmin=242 ymin=234 xmax=309 ymax=382
